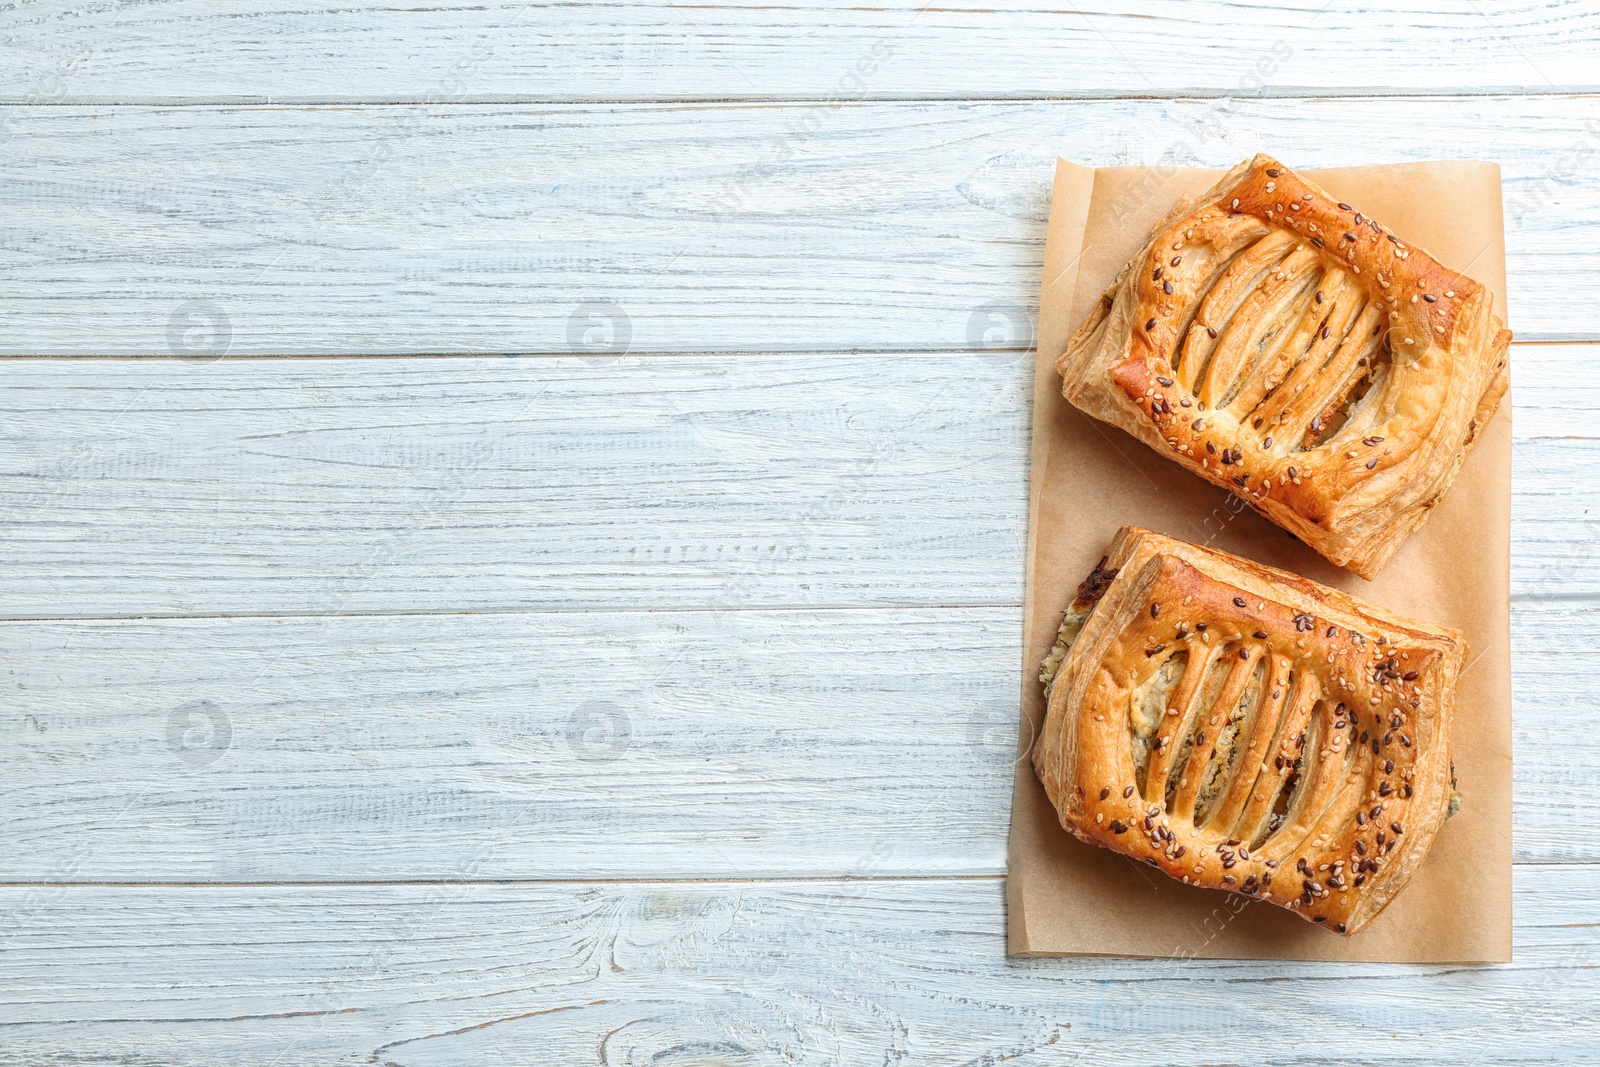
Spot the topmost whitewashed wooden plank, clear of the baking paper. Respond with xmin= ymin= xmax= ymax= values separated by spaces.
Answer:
xmin=0 ymin=0 xmax=1600 ymax=102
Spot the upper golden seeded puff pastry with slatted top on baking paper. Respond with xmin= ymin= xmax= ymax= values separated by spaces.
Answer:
xmin=1056 ymin=155 xmax=1510 ymax=577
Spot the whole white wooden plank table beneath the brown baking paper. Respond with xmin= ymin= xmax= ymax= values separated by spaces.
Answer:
xmin=0 ymin=0 xmax=1600 ymax=1067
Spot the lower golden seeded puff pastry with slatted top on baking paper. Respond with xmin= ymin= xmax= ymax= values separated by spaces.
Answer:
xmin=1034 ymin=526 xmax=1467 ymax=934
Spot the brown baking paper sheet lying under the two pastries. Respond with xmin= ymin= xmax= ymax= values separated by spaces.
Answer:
xmin=1006 ymin=160 xmax=1512 ymax=963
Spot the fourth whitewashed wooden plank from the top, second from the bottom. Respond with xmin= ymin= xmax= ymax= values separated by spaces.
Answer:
xmin=0 ymin=605 xmax=1600 ymax=881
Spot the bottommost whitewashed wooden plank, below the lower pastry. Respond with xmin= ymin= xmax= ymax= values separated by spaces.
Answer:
xmin=0 ymin=865 xmax=1600 ymax=1067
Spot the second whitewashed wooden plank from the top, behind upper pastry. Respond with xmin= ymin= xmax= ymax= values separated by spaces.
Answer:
xmin=0 ymin=96 xmax=1600 ymax=360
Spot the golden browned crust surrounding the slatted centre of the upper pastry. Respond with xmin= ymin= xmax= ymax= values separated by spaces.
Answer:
xmin=1058 ymin=155 xmax=1510 ymax=577
